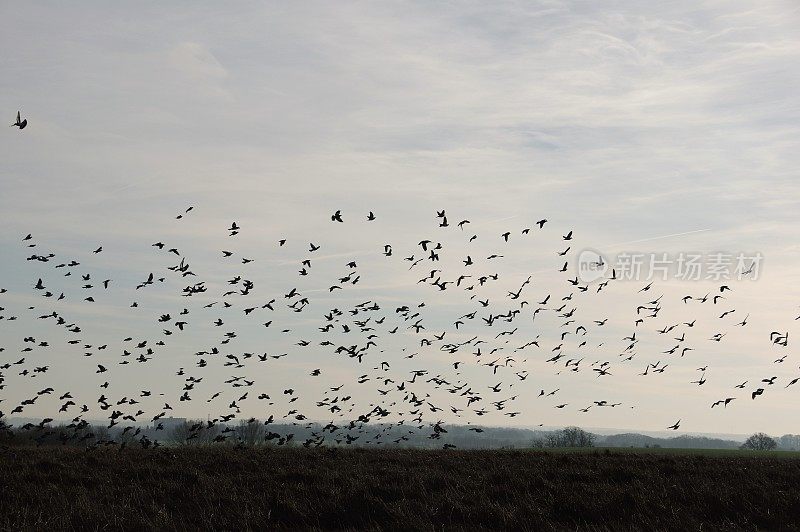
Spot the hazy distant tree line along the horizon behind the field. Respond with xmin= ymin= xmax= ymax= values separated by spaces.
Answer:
xmin=0 ymin=420 xmax=800 ymax=451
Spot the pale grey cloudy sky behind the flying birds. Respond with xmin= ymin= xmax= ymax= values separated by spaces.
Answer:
xmin=0 ymin=1 xmax=800 ymax=434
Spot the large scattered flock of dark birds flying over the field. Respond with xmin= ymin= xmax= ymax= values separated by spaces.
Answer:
xmin=0 ymin=113 xmax=800 ymax=446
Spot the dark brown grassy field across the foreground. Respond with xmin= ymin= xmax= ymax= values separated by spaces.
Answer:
xmin=0 ymin=447 xmax=800 ymax=530
